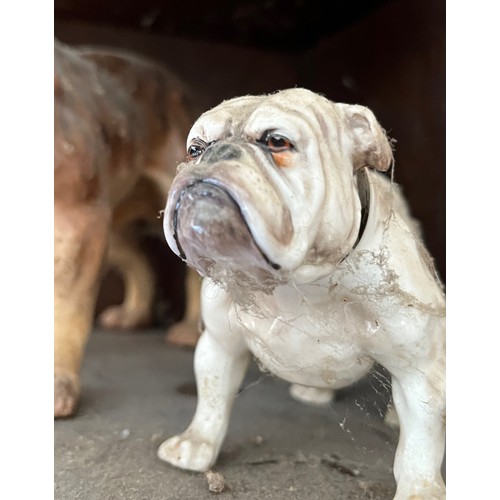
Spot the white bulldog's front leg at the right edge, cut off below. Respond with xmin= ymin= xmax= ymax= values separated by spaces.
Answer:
xmin=392 ymin=362 xmax=445 ymax=500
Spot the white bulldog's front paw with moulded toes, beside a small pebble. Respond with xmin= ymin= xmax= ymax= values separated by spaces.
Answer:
xmin=158 ymin=432 xmax=217 ymax=472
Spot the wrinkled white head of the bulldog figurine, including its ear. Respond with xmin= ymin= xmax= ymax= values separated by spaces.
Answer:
xmin=164 ymin=89 xmax=392 ymax=289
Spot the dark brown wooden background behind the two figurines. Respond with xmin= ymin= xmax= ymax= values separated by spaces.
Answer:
xmin=55 ymin=0 xmax=446 ymax=323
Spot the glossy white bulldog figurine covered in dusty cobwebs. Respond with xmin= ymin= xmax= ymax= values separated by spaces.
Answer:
xmin=158 ymin=88 xmax=445 ymax=500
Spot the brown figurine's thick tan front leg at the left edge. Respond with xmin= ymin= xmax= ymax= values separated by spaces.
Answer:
xmin=54 ymin=204 xmax=110 ymax=417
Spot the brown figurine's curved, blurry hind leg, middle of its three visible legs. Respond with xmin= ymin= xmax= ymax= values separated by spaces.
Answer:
xmin=97 ymin=233 xmax=155 ymax=329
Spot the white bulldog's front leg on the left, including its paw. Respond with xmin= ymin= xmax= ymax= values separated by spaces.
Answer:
xmin=158 ymin=329 xmax=250 ymax=471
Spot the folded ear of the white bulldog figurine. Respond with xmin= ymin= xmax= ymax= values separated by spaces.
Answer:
xmin=339 ymin=104 xmax=393 ymax=172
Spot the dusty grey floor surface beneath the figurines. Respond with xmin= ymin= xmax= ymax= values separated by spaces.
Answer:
xmin=54 ymin=330 xmax=404 ymax=500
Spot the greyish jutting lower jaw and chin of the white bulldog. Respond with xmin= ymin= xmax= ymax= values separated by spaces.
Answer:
xmin=172 ymin=180 xmax=280 ymax=276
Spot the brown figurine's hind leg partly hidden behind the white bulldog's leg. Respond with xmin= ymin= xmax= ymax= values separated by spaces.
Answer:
xmin=165 ymin=267 xmax=201 ymax=347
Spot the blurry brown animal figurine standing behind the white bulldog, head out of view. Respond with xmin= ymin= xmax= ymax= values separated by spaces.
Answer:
xmin=54 ymin=40 xmax=200 ymax=417
